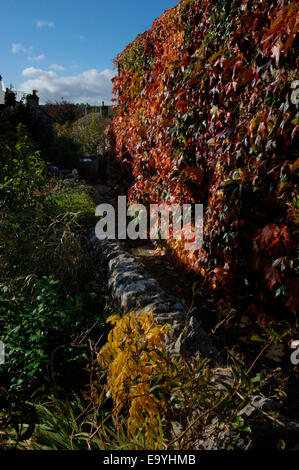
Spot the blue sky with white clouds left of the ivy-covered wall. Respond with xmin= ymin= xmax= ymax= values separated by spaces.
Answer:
xmin=0 ymin=0 xmax=178 ymax=104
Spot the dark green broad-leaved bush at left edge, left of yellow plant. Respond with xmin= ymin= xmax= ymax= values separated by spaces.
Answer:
xmin=0 ymin=276 xmax=101 ymax=402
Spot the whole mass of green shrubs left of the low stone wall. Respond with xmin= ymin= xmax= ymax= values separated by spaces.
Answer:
xmin=0 ymin=130 xmax=102 ymax=407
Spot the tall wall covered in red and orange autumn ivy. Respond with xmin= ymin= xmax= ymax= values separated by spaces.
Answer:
xmin=113 ymin=0 xmax=299 ymax=315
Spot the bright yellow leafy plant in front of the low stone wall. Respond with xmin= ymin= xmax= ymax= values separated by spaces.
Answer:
xmin=97 ymin=312 xmax=170 ymax=443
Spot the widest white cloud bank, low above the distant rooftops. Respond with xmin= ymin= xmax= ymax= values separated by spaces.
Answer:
xmin=20 ymin=64 xmax=115 ymax=104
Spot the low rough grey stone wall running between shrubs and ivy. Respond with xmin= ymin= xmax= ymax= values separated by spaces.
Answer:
xmin=90 ymin=231 xmax=220 ymax=362
